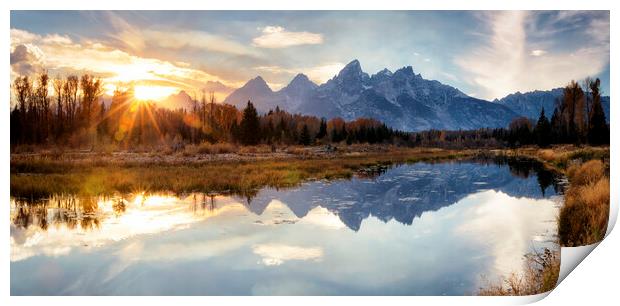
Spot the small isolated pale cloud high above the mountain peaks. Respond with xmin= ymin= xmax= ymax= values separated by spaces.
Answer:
xmin=252 ymin=26 xmax=323 ymax=49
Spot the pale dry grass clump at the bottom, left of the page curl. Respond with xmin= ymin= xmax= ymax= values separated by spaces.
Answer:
xmin=478 ymin=249 xmax=560 ymax=296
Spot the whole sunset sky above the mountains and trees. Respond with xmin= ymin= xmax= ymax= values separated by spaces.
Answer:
xmin=10 ymin=11 xmax=610 ymax=101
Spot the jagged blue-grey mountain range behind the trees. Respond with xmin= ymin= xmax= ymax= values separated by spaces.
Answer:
xmin=164 ymin=60 xmax=609 ymax=131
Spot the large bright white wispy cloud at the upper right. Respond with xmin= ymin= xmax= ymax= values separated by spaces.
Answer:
xmin=455 ymin=11 xmax=609 ymax=100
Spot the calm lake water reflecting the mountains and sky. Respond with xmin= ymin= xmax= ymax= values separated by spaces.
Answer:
xmin=11 ymin=162 xmax=561 ymax=295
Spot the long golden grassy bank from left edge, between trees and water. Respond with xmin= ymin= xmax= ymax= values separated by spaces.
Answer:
xmin=11 ymin=149 xmax=477 ymax=198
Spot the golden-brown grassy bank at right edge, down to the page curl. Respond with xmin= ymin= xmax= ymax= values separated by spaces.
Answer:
xmin=478 ymin=146 xmax=610 ymax=295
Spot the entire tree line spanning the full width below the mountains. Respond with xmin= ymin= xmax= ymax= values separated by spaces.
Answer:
xmin=10 ymin=73 xmax=609 ymax=148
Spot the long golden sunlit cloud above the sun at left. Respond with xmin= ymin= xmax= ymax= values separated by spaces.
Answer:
xmin=11 ymin=29 xmax=237 ymax=99
